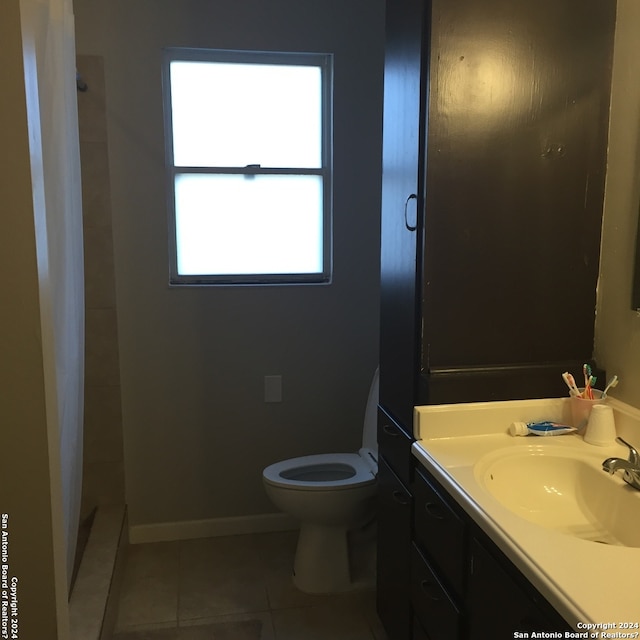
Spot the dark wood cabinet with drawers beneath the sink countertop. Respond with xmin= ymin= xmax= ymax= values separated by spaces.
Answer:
xmin=406 ymin=468 xmax=570 ymax=640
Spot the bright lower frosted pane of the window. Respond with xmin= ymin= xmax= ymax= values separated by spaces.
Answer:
xmin=175 ymin=174 xmax=323 ymax=276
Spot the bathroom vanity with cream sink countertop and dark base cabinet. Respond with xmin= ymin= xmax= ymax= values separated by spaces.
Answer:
xmin=411 ymin=399 xmax=640 ymax=640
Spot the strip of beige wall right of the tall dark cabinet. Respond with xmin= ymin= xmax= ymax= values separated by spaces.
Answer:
xmin=595 ymin=0 xmax=640 ymax=407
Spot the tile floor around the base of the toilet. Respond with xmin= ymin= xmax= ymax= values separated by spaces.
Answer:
xmin=113 ymin=531 xmax=386 ymax=640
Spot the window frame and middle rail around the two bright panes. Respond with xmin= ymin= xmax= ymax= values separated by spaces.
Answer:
xmin=162 ymin=47 xmax=333 ymax=285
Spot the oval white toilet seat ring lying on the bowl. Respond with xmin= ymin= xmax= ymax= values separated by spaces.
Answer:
xmin=262 ymin=449 xmax=376 ymax=491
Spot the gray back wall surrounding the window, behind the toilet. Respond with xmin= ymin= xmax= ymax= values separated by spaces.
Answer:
xmin=75 ymin=0 xmax=384 ymax=525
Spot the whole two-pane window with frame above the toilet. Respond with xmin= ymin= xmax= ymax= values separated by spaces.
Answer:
xmin=163 ymin=49 xmax=332 ymax=284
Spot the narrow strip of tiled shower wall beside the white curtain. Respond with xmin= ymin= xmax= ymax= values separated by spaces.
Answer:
xmin=77 ymin=55 xmax=125 ymax=517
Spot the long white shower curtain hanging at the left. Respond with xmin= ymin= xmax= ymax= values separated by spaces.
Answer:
xmin=20 ymin=0 xmax=84 ymax=587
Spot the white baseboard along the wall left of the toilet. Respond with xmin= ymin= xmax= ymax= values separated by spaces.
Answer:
xmin=129 ymin=513 xmax=300 ymax=544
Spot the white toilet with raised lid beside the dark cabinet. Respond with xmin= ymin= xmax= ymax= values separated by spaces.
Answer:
xmin=262 ymin=370 xmax=379 ymax=593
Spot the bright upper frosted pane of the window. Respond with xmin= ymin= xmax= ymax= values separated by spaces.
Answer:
xmin=171 ymin=61 xmax=322 ymax=168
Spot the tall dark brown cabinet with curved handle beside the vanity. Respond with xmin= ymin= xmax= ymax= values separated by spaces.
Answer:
xmin=378 ymin=0 xmax=615 ymax=640
